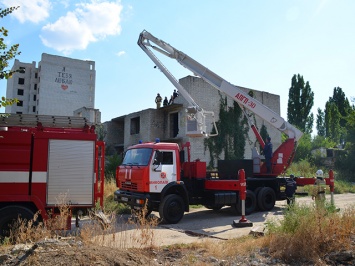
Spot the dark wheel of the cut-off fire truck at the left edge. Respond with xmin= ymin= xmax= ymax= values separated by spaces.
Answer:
xmin=0 ymin=205 xmax=34 ymax=237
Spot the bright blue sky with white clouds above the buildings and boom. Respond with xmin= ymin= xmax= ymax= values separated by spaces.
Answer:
xmin=0 ymin=0 xmax=355 ymax=131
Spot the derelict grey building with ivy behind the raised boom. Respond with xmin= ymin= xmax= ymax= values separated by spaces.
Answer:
xmin=105 ymin=76 xmax=281 ymax=166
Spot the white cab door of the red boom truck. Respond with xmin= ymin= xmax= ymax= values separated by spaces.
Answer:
xmin=149 ymin=150 xmax=177 ymax=193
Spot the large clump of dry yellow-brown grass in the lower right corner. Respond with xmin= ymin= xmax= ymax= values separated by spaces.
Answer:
xmin=263 ymin=205 xmax=355 ymax=263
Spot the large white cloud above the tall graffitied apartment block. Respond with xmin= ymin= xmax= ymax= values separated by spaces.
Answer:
xmin=40 ymin=0 xmax=122 ymax=54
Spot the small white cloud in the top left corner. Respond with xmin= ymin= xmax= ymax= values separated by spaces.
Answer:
xmin=1 ymin=0 xmax=51 ymax=23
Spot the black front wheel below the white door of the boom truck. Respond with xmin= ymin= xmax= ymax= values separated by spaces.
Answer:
xmin=159 ymin=194 xmax=185 ymax=224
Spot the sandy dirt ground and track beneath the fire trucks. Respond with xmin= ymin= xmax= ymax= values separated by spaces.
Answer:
xmin=0 ymin=194 xmax=355 ymax=265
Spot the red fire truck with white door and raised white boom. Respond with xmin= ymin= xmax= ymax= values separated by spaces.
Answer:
xmin=114 ymin=31 xmax=334 ymax=223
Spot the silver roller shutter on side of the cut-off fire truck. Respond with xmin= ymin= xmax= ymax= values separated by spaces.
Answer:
xmin=47 ymin=140 xmax=95 ymax=205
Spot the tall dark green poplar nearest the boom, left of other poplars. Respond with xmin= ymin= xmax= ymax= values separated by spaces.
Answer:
xmin=287 ymin=74 xmax=314 ymax=133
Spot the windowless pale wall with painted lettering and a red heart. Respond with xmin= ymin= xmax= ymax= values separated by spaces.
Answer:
xmin=38 ymin=54 xmax=95 ymax=116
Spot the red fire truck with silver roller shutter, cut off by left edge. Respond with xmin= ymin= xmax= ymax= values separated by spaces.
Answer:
xmin=0 ymin=114 xmax=105 ymax=236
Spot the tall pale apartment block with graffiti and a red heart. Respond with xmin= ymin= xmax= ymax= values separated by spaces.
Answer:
xmin=5 ymin=53 xmax=100 ymax=122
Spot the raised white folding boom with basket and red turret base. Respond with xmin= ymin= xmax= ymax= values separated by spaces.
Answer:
xmin=138 ymin=31 xmax=303 ymax=177
